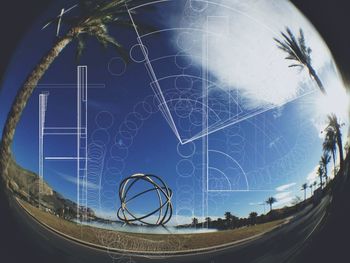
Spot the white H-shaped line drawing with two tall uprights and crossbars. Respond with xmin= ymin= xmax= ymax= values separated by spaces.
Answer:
xmin=39 ymin=66 xmax=88 ymax=221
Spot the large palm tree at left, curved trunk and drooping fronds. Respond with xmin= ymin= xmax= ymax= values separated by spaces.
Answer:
xmin=0 ymin=0 xmax=147 ymax=176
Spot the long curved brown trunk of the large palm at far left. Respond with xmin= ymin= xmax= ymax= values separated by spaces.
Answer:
xmin=0 ymin=28 xmax=79 ymax=178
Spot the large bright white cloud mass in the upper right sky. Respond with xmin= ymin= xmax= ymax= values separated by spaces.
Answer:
xmin=173 ymin=0 xmax=332 ymax=109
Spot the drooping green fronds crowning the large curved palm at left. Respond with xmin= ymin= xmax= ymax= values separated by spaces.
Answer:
xmin=44 ymin=0 xmax=156 ymax=63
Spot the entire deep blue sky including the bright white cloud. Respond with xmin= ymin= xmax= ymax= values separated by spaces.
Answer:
xmin=0 ymin=0 xmax=348 ymax=227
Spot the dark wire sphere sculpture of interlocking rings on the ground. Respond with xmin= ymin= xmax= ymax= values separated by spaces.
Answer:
xmin=117 ymin=174 xmax=173 ymax=226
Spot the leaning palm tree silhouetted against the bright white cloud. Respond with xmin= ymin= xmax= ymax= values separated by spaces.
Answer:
xmin=274 ymin=27 xmax=327 ymax=95
